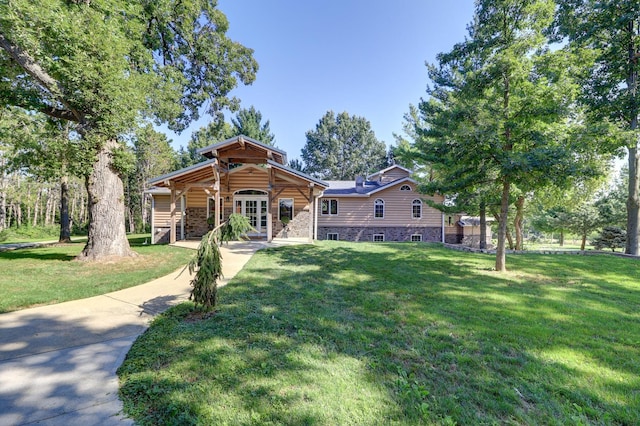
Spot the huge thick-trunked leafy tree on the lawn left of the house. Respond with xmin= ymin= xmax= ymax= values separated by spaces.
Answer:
xmin=0 ymin=0 xmax=257 ymax=259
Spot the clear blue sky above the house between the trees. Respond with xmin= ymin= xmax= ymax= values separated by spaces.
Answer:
xmin=166 ymin=0 xmax=473 ymax=159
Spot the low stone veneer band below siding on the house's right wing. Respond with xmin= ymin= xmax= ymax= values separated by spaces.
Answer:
xmin=318 ymin=226 xmax=442 ymax=243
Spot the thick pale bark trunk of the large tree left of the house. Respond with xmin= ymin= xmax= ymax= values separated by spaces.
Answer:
xmin=78 ymin=139 xmax=136 ymax=260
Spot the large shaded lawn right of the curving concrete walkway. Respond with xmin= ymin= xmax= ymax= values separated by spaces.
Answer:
xmin=119 ymin=242 xmax=640 ymax=425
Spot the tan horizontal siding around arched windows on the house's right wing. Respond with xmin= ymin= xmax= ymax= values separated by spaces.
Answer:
xmin=318 ymin=185 xmax=442 ymax=227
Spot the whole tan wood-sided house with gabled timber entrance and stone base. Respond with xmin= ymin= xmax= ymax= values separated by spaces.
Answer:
xmin=147 ymin=136 xmax=484 ymax=243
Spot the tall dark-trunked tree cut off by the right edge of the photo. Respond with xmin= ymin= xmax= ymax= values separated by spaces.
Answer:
xmin=555 ymin=0 xmax=640 ymax=255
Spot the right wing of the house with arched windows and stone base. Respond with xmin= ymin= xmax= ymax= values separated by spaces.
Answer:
xmin=316 ymin=165 xmax=445 ymax=242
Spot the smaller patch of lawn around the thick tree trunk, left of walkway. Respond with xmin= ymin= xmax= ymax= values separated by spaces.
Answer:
xmin=0 ymin=235 xmax=194 ymax=313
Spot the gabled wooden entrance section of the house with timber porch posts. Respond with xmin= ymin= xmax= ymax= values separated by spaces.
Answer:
xmin=147 ymin=136 xmax=328 ymax=243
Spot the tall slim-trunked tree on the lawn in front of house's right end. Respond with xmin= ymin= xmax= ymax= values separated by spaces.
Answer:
xmin=408 ymin=0 xmax=589 ymax=271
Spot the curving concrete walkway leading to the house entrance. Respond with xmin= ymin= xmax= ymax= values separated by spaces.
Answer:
xmin=0 ymin=240 xmax=302 ymax=426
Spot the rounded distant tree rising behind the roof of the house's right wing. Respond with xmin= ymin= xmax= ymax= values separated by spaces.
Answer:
xmin=302 ymin=111 xmax=387 ymax=180
